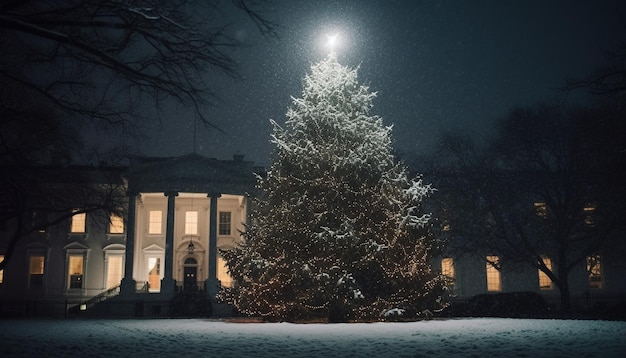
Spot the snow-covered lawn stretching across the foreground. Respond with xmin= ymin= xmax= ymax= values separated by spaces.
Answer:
xmin=0 ymin=318 xmax=626 ymax=358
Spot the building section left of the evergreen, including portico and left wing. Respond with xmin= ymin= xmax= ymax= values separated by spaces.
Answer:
xmin=0 ymin=154 xmax=256 ymax=316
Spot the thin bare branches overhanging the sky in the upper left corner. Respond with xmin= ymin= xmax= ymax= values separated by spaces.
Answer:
xmin=0 ymin=0 xmax=274 ymax=128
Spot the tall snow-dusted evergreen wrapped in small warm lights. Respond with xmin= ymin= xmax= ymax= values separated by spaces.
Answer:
xmin=220 ymin=54 xmax=445 ymax=321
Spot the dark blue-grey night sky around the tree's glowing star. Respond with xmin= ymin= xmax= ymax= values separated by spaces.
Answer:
xmin=136 ymin=0 xmax=626 ymax=165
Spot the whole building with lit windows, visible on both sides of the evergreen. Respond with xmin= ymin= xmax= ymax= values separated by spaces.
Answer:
xmin=0 ymin=154 xmax=626 ymax=316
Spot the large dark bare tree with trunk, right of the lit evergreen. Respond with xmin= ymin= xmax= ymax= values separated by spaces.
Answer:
xmin=433 ymin=105 xmax=626 ymax=312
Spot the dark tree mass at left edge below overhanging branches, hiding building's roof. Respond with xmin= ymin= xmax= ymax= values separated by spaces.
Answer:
xmin=0 ymin=88 xmax=127 ymax=270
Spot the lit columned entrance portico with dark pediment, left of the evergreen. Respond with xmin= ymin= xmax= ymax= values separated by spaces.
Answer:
xmin=121 ymin=153 xmax=255 ymax=298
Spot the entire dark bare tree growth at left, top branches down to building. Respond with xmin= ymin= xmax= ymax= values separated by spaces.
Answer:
xmin=0 ymin=0 xmax=273 ymax=269
